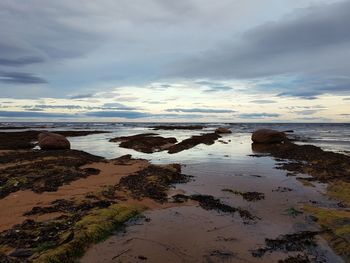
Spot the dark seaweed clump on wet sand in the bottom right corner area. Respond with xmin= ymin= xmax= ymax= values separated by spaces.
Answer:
xmin=252 ymin=231 xmax=321 ymax=257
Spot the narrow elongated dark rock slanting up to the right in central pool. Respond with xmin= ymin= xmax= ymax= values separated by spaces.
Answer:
xmin=168 ymin=133 xmax=221 ymax=154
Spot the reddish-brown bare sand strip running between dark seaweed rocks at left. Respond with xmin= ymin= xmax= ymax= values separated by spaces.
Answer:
xmin=0 ymin=160 xmax=149 ymax=231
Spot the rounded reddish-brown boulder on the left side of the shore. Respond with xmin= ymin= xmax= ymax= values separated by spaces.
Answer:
xmin=38 ymin=132 xmax=70 ymax=150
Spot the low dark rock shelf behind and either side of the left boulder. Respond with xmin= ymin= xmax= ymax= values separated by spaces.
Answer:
xmin=0 ymin=130 xmax=106 ymax=150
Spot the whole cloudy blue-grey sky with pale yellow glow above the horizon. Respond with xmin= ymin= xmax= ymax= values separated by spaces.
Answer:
xmin=0 ymin=0 xmax=350 ymax=122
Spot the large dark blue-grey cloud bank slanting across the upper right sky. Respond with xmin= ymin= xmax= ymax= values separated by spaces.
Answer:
xmin=169 ymin=1 xmax=350 ymax=99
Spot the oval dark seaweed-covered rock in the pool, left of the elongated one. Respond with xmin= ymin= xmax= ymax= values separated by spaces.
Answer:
xmin=109 ymin=133 xmax=177 ymax=153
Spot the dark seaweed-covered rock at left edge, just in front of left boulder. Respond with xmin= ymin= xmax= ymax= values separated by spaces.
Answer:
xmin=0 ymin=150 xmax=104 ymax=198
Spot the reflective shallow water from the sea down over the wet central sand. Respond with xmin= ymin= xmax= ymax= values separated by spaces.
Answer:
xmin=0 ymin=124 xmax=350 ymax=263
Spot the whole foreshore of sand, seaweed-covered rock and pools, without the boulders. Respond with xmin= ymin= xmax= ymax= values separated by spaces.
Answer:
xmin=0 ymin=125 xmax=350 ymax=263
